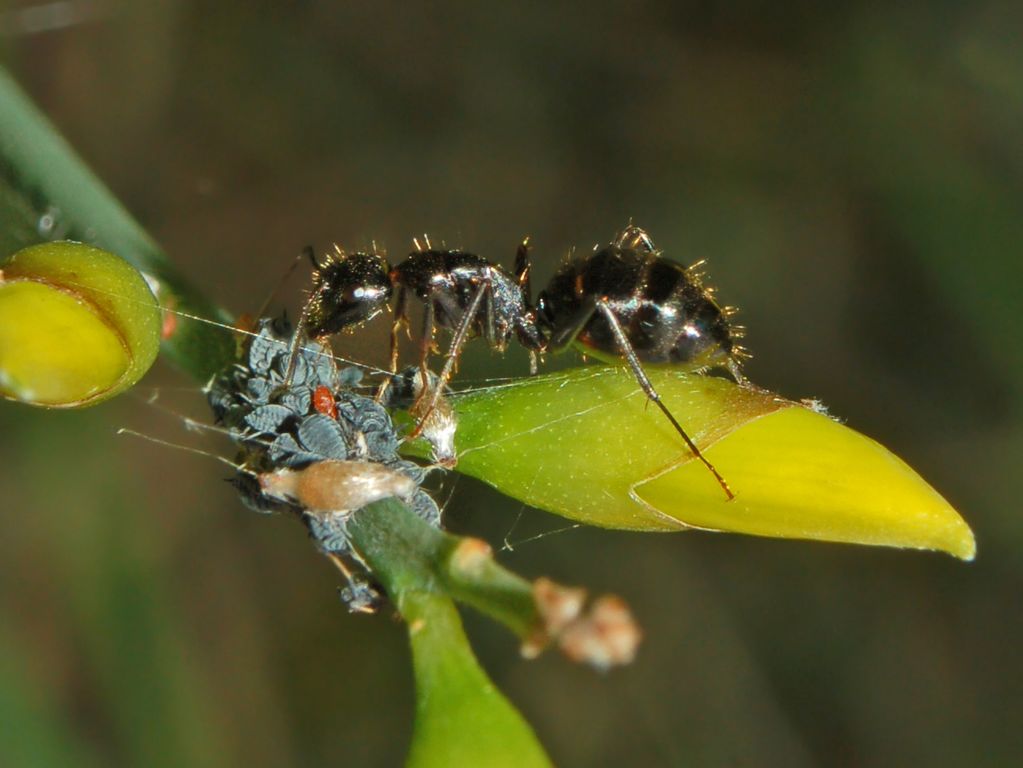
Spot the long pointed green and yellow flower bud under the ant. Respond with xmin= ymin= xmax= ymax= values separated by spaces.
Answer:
xmin=452 ymin=367 xmax=975 ymax=559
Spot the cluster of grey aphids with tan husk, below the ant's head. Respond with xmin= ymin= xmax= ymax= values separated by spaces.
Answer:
xmin=208 ymin=319 xmax=440 ymax=611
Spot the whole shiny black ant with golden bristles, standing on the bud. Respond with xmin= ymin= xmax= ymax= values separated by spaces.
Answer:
xmin=293 ymin=224 xmax=746 ymax=499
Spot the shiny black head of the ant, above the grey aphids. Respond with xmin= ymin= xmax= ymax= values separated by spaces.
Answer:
xmin=305 ymin=246 xmax=392 ymax=337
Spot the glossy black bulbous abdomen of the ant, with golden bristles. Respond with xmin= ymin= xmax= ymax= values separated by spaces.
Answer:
xmin=537 ymin=227 xmax=745 ymax=378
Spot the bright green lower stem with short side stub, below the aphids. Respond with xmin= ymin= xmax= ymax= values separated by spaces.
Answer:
xmin=348 ymin=499 xmax=550 ymax=768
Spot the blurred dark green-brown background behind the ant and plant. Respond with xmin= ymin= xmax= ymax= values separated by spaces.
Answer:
xmin=0 ymin=0 xmax=1023 ymax=766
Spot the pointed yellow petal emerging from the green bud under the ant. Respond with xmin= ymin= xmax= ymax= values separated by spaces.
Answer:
xmin=633 ymin=405 xmax=976 ymax=560
